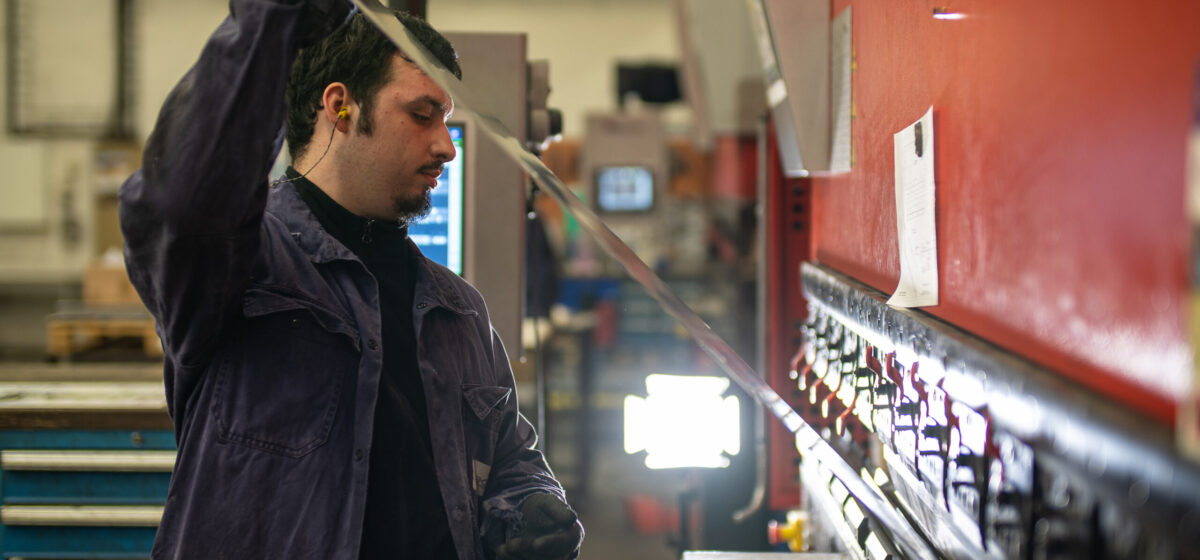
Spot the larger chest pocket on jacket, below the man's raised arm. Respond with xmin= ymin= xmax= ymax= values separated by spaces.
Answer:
xmin=212 ymin=289 xmax=360 ymax=457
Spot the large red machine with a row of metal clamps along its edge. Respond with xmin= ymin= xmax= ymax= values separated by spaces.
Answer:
xmin=762 ymin=0 xmax=1200 ymax=558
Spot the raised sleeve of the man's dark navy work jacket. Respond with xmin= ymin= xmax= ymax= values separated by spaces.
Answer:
xmin=120 ymin=0 xmax=344 ymax=414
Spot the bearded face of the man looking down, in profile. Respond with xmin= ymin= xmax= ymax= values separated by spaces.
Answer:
xmin=344 ymin=55 xmax=455 ymax=219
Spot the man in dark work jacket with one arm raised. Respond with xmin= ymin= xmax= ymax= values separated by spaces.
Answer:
xmin=120 ymin=0 xmax=582 ymax=560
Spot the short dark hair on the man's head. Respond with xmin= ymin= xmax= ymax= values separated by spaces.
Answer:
xmin=287 ymin=11 xmax=462 ymax=159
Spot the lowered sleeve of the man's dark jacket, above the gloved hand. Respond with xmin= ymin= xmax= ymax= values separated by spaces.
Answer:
xmin=480 ymin=329 xmax=578 ymax=558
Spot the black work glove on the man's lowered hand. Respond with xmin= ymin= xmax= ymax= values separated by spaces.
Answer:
xmin=496 ymin=493 xmax=583 ymax=560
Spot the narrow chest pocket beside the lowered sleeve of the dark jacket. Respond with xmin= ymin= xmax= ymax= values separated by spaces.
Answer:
xmin=462 ymin=384 xmax=512 ymax=495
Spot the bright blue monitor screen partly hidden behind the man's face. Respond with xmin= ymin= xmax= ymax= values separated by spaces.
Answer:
xmin=408 ymin=122 xmax=466 ymax=275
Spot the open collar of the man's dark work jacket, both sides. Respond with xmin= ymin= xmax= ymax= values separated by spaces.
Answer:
xmin=266 ymin=182 xmax=476 ymax=315
